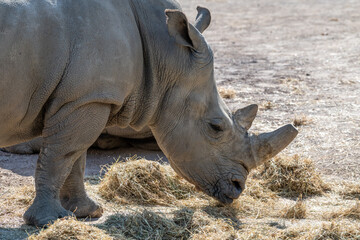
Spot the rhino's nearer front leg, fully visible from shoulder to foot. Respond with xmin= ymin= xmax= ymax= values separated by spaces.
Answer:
xmin=24 ymin=103 xmax=110 ymax=226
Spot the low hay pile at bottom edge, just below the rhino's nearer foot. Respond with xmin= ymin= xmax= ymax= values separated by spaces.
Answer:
xmin=28 ymin=218 xmax=113 ymax=240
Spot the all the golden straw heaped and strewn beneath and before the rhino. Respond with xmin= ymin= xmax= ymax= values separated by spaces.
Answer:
xmin=14 ymin=156 xmax=360 ymax=240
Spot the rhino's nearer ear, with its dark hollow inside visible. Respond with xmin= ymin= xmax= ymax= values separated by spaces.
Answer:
xmin=165 ymin=9 xmax=205 ymax=52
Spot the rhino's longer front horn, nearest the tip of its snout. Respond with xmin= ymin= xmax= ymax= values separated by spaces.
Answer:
xmin=251 ymin=124 xmax=298 ymax=166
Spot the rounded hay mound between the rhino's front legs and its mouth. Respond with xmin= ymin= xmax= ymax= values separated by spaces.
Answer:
xmin=99 ymin=158 xmax=194 ymax=205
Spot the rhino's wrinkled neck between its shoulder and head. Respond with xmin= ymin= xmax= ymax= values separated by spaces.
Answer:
xmin=122 ymin=0 xmax=183 ymax=130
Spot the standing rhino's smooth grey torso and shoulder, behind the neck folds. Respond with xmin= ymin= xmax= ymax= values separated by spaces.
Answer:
xmin=0 ymin=0 xmax=142 ymax=146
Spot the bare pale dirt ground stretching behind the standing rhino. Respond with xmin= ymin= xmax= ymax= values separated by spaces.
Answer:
xmin=0 ymin=0 xmax=360 ymax=239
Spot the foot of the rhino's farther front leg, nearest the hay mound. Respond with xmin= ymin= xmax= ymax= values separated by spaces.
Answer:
xmin=61 ymin=196 xmax=103 ymax=218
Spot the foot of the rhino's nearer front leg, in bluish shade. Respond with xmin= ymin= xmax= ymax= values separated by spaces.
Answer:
xmin=23 ymin=199 xmax=73 ymax=227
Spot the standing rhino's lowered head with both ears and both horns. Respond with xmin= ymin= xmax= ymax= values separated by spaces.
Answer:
xmin=151 ymin=7 xmax=297 ymax=203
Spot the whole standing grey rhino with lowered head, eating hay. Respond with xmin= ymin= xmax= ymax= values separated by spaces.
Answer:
xmin=0 ymin=0 xmax=297 ymax=226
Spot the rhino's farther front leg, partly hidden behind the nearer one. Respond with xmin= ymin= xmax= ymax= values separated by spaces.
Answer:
xmin=60 ymin=153 xmax=103 ymax=218
